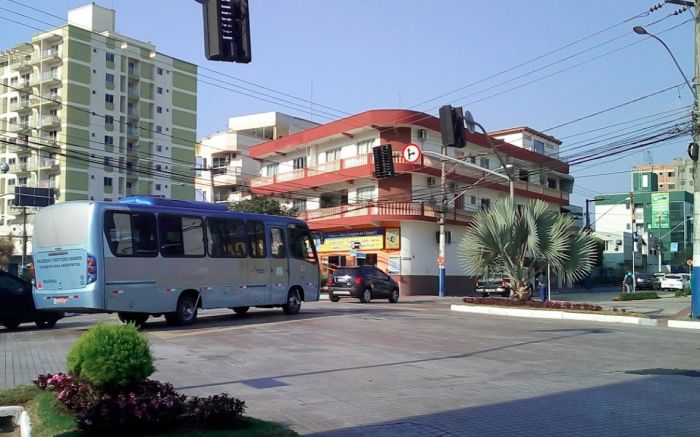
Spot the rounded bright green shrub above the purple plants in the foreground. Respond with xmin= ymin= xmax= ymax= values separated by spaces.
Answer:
xmin=68 ymin=323 xmax=155 ymax=388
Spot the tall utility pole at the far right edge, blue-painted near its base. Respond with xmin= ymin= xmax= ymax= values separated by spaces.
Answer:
xmin=690 ymin=0 xmax=700 ymax=319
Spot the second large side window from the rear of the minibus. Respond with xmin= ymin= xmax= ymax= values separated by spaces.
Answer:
xmin=158 ymin=214 xmax=204 ymax=257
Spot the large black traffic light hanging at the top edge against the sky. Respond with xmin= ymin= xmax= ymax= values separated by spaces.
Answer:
xmin=196 ymin=0 xmax=251 ymax=64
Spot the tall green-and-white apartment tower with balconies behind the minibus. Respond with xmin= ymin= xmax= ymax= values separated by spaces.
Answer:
xmin=0 ymin=3 xmax=197 ymax=268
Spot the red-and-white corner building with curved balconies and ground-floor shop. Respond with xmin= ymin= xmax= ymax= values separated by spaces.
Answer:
xmin=249 ymin=109 xmax=573 ymax=295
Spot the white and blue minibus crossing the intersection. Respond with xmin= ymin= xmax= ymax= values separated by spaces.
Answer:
xmin=32 ymin=196 xmax=320 ymax=325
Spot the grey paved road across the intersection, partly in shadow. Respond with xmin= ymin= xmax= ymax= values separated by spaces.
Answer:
xmin=0 ymin=298 xmax=700 ymax=436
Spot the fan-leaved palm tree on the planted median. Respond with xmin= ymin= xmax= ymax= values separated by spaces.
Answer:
xmin=458 ymin=199 xmax=596 ymax=300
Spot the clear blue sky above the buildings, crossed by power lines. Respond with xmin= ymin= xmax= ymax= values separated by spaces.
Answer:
xmin=0 ymin=0 xmax=694 ymax=204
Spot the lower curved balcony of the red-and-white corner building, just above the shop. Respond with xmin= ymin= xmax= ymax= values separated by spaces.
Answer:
xmin=297 ymin=201 xmax=474 ymax=226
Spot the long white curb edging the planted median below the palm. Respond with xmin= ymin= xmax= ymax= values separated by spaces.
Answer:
xmin=450 ymin=304 xmax=660 ymax=329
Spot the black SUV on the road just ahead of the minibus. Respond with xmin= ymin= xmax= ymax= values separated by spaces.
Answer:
xmin=328 ymin=266 xmax=399 ymax=303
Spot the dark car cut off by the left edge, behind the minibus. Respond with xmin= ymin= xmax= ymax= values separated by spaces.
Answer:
xmin=0 ymin=270 xmax=64 ymax=329
